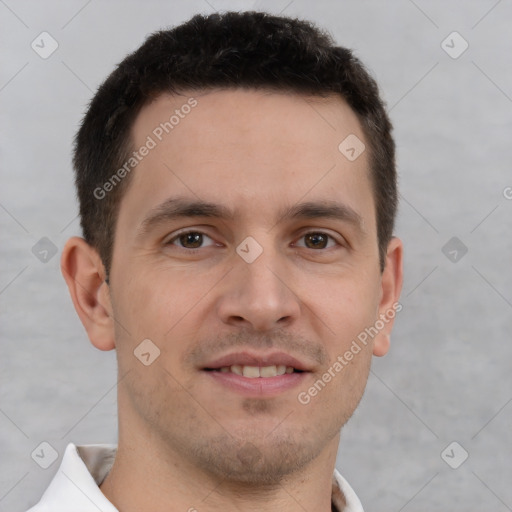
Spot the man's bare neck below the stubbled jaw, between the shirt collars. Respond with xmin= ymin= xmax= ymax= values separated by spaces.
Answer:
xmin=100 ymin=422 xmax=339 ymax=512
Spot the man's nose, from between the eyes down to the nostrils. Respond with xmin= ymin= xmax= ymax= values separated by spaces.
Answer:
xmin=217 ymin=243 xmax=301 ymax=332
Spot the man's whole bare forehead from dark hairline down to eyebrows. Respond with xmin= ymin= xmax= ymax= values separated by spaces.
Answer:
xmin=120 ymin=89 xmax=373 ymax=234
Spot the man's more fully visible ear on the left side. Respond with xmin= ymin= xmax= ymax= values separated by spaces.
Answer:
xmin=60 ymin=237 xmax=115 ymax=350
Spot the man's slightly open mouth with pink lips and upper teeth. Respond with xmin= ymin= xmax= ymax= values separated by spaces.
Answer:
xmin=202 ymin=353 xmax=311 ymax=397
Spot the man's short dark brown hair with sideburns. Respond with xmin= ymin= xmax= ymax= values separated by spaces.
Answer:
xmin=73 ymin=11 xmax=397 ymax=274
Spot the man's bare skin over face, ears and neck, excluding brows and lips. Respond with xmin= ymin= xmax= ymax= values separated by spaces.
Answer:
xmin=62 ymin=90 xmax=402 ymax=512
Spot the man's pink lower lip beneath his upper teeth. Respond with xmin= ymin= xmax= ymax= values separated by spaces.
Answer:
xmin=205 ymin=371 xmax=308 ymax=397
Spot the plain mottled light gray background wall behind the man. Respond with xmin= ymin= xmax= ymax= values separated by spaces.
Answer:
xmin=0 ymin=0 xmax=512 ymax=512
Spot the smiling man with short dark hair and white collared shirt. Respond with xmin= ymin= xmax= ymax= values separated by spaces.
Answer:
xmin=27 ymin=12 xmax=402 ymax=512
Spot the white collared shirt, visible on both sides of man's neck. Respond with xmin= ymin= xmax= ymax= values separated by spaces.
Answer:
xmin=27 ymin=443 xmax=363 ymax=512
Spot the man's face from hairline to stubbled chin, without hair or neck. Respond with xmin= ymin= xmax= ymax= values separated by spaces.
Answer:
xmin=101 ymin=90 xmax=396 ymax=481
